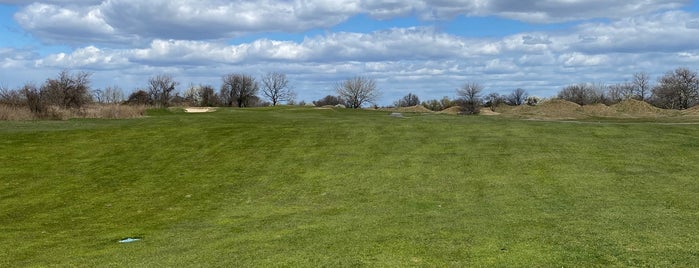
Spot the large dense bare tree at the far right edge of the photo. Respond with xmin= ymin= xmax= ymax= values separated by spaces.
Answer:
xmin=653 ymin=67 xmax=699 ymax=110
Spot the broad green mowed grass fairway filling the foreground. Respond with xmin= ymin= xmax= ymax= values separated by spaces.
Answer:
xmin=0 ymin=108 xmax=699 ymax=267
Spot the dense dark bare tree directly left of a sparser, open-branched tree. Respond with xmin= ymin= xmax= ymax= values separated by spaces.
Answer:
xmin=220 ymin=74 xmax=259 ymax=107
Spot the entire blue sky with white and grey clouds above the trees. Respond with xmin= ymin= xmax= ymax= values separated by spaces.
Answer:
xmin=0 ymin=0 xmax=699 ymax=105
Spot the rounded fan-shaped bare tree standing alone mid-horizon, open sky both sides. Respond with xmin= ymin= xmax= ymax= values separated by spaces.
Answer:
xmin=335 ymin=76 xmax=379 ymax=109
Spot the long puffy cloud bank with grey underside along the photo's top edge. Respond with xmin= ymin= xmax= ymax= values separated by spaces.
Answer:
xmin=8 ymin=0 xmax=688 ymax=43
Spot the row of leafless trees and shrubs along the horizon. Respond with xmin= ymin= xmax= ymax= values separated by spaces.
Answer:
xmin=0 ymin=67 xmax=699 ymax=117
